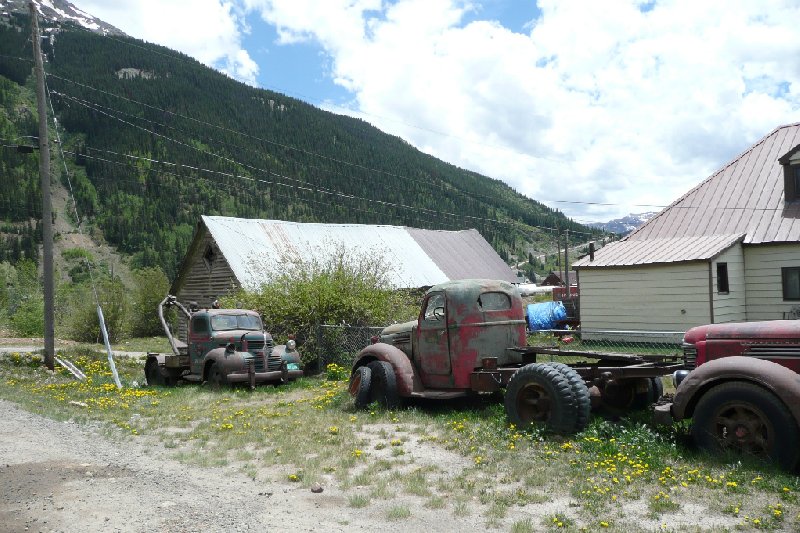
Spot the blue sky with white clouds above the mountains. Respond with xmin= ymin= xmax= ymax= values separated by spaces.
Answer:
xmin=67 ymin=0 xmax=800 ymax=222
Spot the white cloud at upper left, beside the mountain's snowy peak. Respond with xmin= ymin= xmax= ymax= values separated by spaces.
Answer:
xmin=72 ymin=0 xmax=258 ymax=85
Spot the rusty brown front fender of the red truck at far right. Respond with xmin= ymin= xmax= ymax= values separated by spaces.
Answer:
xmin=672 ymin=356 xmax=800 ymax=425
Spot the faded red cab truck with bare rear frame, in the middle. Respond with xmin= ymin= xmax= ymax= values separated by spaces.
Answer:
xmin=349 ymin=280 xmax=683 ymax=434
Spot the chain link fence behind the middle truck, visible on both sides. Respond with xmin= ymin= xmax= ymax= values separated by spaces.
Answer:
xmin=310 ymin=324 xmax=683 ymax=372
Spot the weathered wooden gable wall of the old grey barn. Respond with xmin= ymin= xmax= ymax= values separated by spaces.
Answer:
xmin=175 ymin=231 xmax=240 ymax=338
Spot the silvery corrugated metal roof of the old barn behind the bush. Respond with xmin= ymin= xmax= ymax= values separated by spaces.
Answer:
xmin=202 ymin=216 xmax=516 ymax=288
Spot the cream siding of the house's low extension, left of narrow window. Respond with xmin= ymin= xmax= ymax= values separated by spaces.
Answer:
xmin=579 ymin=261 xmax=711 ymax=331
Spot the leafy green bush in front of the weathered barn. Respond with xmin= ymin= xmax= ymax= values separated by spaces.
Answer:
xmin=222 ymin=246 xmax=419 ymax=363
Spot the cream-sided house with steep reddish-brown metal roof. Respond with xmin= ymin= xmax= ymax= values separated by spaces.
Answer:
xmin=573 ymin=123 xmax=800 ymax=331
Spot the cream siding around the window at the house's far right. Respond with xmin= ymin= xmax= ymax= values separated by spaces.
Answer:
xmin=744 ymin=244 xmax=800 ymax=320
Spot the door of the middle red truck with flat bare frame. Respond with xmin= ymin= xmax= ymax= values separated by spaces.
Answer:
xmin=417 ymin=292 xmax=451 ymax=380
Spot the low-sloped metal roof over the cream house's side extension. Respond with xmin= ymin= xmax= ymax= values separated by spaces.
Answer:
xmin=574 ymin=233 xmax=744 ymax=267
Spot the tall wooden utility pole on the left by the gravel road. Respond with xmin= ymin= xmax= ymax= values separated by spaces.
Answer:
xmin=29 ymin=2 xmax=56 ymax=370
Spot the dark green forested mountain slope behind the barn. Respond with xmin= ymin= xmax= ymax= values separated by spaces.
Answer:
xmin=0 ymin=8 xmax=597 ymax=277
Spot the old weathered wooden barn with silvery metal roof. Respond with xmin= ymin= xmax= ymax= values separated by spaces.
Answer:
xmin=172 ymin=216 xmax=517 ymax=306
